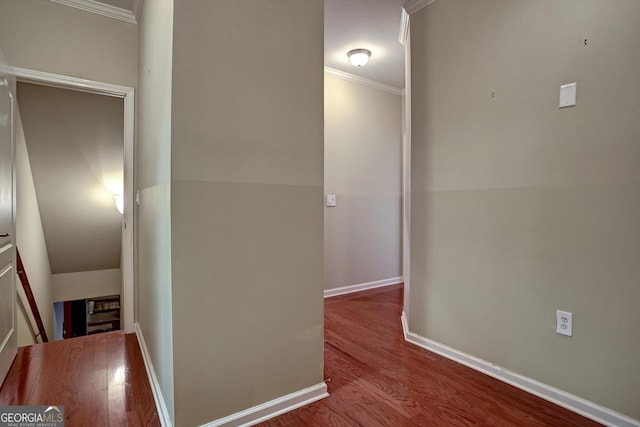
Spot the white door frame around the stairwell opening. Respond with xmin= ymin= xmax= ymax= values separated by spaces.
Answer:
xmin=11 ymin=67 xmax=135 ymax=333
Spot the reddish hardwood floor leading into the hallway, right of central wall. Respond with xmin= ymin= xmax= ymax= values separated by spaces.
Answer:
xmin=260 ymin=285 xmax=600 ymax=427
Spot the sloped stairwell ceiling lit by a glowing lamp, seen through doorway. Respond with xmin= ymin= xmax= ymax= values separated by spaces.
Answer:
xmin=17 ymin=82 xmax=124 ymax=274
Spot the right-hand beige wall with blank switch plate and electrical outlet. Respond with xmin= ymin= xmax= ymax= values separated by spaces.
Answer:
xmin=409 ymin=0 xmax=640 ymax=419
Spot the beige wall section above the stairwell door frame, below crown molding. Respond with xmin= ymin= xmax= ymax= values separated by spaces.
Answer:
xmin=0 ymin=0 xmax=138 ymax=87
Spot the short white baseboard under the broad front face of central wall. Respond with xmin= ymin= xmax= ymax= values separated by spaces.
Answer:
xmin=201 ymin=382 xmax=329 ymax=427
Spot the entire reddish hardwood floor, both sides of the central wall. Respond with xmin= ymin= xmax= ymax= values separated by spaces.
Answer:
xmin=0 ymin=285 xmax=599 ymax=427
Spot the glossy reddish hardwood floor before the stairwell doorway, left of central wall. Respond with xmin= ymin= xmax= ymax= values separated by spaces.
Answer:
xmin=0 ymin=332 xmax=160 ymax=427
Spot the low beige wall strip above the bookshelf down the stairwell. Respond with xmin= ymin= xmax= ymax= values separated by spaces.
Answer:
xmin=53 ymin=268 xmax=122 ymax=302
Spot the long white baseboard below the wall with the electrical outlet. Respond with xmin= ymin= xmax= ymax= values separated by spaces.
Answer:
xmin=401 ymin=311 xmax=640 ymax=427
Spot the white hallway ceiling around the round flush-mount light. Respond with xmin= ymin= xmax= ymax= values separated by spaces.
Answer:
xmin=324 ymin=0 xmax=406 ymax=89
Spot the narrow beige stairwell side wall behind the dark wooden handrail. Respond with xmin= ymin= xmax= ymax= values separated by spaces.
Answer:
xmin=14 ymin=112 xmax=53 ymax=346
